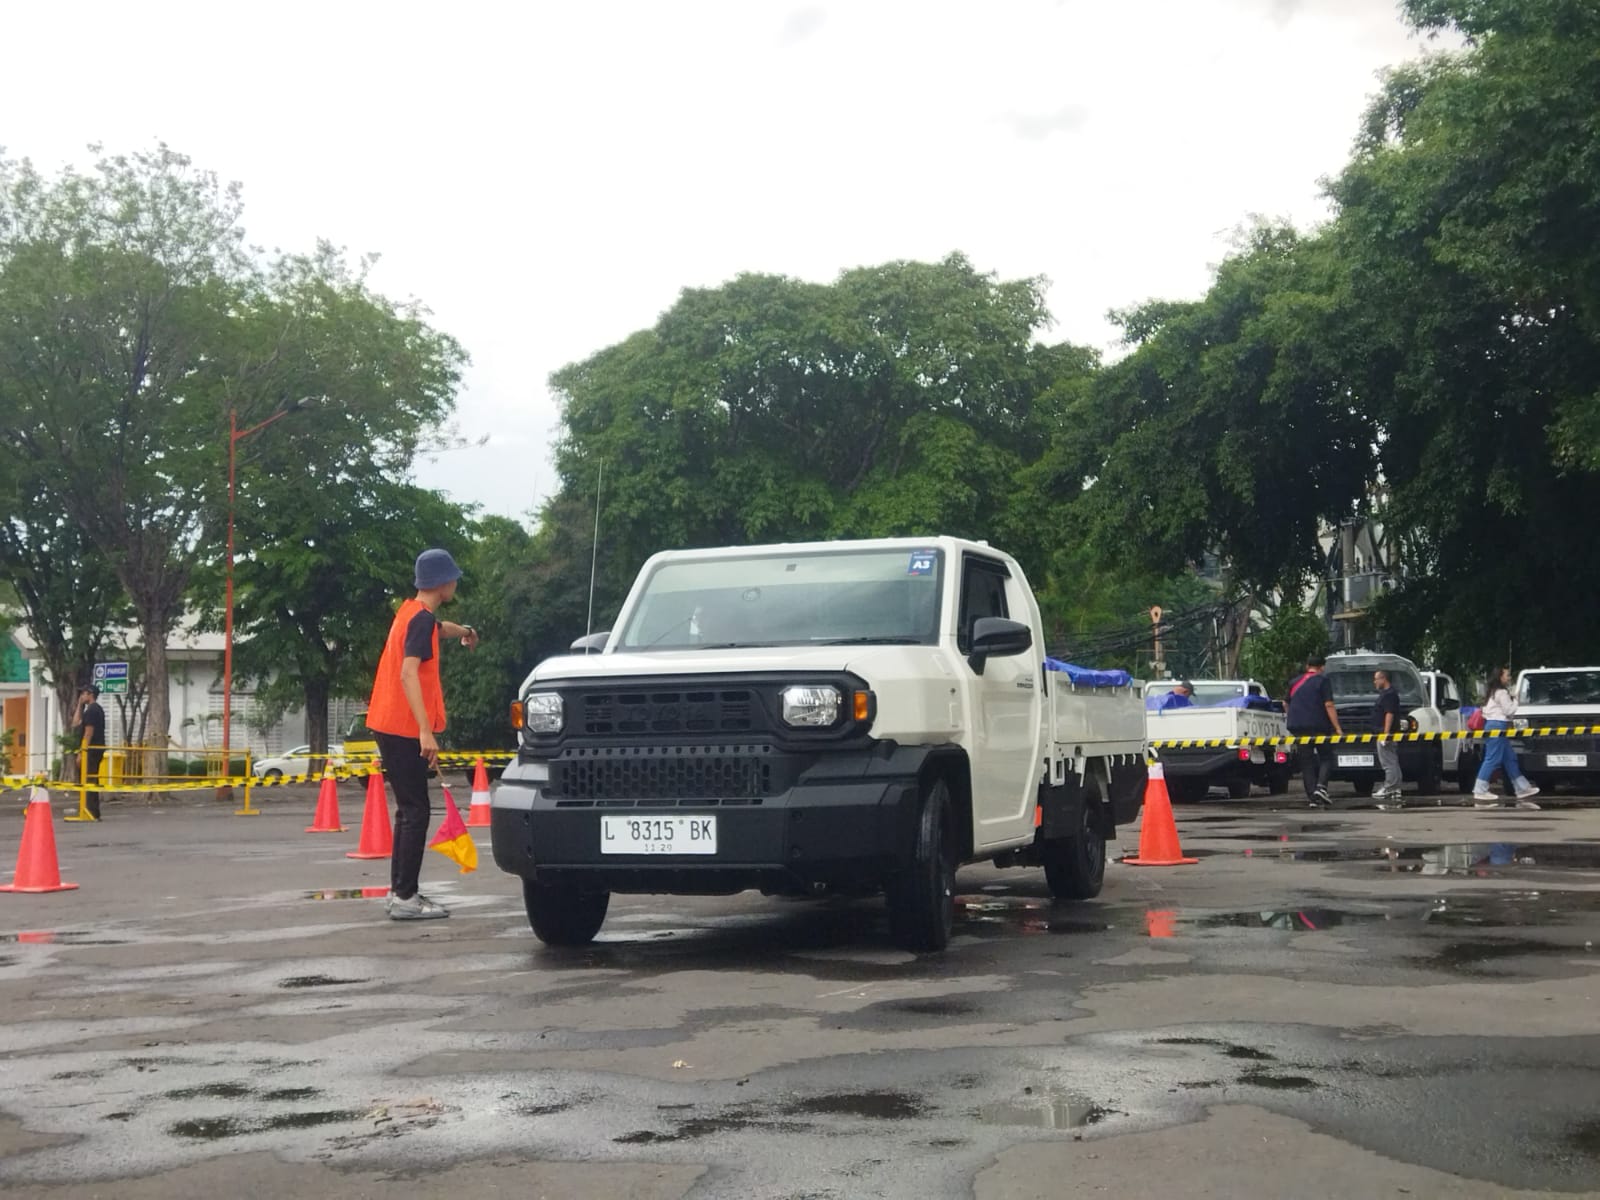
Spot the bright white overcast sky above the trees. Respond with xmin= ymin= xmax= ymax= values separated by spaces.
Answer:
xmin=0 ymin=0 xmax=1424 ymax=517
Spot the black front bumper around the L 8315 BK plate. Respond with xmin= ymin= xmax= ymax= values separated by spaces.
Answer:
xmin=490 ymin=750 xmax=920 ymax=894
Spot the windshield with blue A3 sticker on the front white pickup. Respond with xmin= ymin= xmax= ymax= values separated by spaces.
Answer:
xmin=614 ymin=549 xmax=944 ymax=650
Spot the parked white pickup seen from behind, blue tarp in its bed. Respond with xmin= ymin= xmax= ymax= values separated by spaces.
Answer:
xmin=1144 ymin=678 xmax=1294 ymax=802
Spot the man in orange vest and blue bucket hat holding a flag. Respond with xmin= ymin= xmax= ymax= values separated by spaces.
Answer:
xmin=366 ymin=550 xmax=478 ymax=922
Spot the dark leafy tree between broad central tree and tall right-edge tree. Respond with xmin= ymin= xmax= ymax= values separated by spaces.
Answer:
xmin=1058 ymin=226 xmax=1373 ymax=608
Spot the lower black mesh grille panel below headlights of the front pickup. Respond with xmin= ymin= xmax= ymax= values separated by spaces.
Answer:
xmin=546 ymin=746 xmax=773 ymax=800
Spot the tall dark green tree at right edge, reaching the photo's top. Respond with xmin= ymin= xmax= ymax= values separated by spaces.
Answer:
xmin=1330 ymin=0 xmax=1600 ymax=664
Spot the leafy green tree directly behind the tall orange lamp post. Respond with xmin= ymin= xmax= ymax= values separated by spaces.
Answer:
xmin=212 ymin=245 xmax=466 ymax=755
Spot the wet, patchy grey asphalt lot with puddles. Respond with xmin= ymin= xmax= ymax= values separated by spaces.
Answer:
xmin=0 ymin=789 xmax=1600 ymax=1200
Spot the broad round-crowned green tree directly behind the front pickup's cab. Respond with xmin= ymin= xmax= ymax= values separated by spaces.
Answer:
xmin=552 ymin=254 xmax=1094 ymax=598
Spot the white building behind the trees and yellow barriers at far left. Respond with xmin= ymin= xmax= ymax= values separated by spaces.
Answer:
xmin=0 ymin=626 xmax=366 ymax=774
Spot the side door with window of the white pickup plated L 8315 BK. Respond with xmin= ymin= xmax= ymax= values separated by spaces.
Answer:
xmin=955 ymin=555 xmax=1045 ymax=848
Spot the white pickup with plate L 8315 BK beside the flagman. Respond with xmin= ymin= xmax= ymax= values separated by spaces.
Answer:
xmin=490 ymin=538 xmax=1146 ymax=950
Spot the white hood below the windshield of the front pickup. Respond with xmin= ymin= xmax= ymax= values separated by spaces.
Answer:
xmin=522 ymin=645 xmax=949 ymax=690
